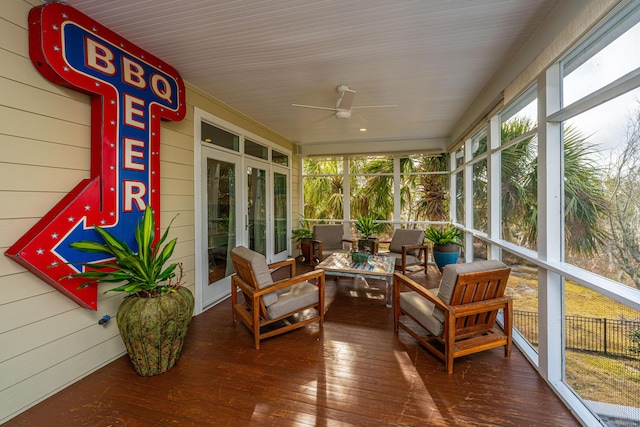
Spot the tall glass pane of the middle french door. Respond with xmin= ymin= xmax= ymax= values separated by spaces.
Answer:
xmin=246 ymin=166 xmax=267 ymax=256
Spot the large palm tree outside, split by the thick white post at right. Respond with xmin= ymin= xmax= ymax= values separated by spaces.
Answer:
xmin=501 ymin=118 xmax=608 ymax=255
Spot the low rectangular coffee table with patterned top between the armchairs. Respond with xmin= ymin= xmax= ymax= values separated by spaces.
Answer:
xmin=315 ymin=252 xmax=396 ymax=307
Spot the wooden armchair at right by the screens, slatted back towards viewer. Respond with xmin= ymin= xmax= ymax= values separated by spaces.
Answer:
xmin=393 ymin=261 xmax=513 ymax=373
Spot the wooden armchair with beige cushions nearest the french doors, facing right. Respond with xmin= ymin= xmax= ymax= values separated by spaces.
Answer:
xmin=231 ymin=246 xmax=325 ymax=349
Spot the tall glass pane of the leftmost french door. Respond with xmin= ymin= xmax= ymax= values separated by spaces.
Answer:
xmin=207 ymin=159 xmax=236 ymax=283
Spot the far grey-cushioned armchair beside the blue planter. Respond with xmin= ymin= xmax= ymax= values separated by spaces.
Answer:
xmin=376 ymin=228 xmax=429 ymax=274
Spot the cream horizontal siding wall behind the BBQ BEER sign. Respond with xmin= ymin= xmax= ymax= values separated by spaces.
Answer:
xmin=0 ymin=0 xmax=297 ymax=423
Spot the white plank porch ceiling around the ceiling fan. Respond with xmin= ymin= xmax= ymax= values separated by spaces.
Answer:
xmin=62 ymin=0 xmax=558 ymax=152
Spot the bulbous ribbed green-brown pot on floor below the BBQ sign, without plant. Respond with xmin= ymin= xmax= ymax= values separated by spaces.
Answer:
xmin=117 ymin=287 xmax=195 ymax=377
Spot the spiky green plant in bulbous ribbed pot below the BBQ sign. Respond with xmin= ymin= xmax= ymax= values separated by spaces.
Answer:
xmin=71 ymin=206 xmax=194 ymax=376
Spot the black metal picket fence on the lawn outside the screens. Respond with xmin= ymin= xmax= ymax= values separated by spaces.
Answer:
xmin=513 ymin=310 xmax=640 ymax=358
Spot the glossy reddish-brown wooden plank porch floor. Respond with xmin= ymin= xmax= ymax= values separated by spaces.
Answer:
xmin=5 ymin=266 xmax=580 ymax=427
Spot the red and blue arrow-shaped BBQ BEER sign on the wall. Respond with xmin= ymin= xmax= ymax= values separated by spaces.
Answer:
xmin=6 ymin=3 xmax=185 ymax=310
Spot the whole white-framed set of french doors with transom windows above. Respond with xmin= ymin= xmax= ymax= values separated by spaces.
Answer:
xmin=194 ymin=108 xmax=291 ymax=313
